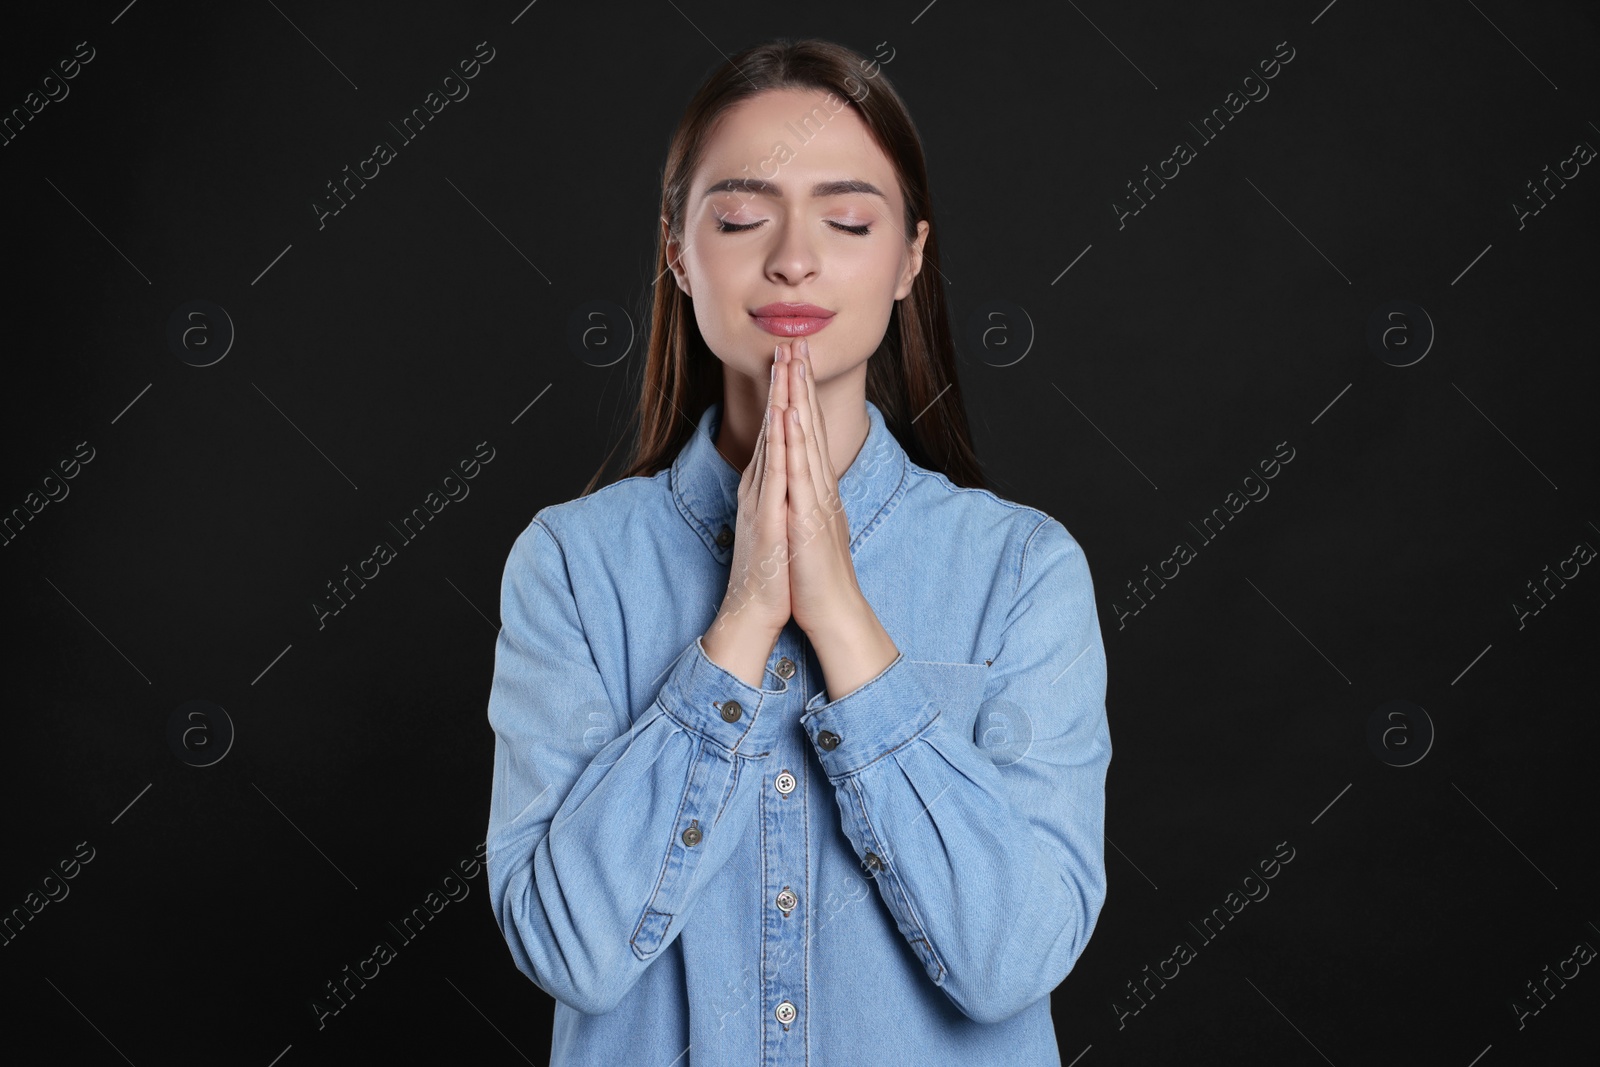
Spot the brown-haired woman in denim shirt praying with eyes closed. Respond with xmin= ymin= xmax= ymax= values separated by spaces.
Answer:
xmin=488 ymin=40 xmax=1110 ymax=1067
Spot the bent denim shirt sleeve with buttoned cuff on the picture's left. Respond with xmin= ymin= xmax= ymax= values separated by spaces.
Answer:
xmin=486 ymin=517 xmax=782 ymax=1014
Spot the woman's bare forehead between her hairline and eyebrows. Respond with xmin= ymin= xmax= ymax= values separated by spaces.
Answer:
xmin=691 ymin=90 xmax=899 ymax=205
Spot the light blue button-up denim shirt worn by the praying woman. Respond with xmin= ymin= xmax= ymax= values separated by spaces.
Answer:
xmin=486 ymin=402 xmax=1110 ymax=1067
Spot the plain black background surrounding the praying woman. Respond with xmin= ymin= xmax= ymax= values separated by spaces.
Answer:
xmin=0 ymin=0 xmax=1600 ymax=1067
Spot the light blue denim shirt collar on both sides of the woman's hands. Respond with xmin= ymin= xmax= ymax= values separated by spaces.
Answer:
xmin=670 ymin=400 xmax=909 ymax=565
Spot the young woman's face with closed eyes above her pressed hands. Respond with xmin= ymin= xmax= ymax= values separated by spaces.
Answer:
xmin=667 ymin=90 xmax=928 ymax=382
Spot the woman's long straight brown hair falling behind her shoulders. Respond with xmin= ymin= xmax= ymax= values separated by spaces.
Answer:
xmin=582 ymin=38 xmax=989 ymax=496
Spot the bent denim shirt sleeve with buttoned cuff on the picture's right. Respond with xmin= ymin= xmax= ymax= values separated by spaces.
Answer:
xmin=800 ymin=518 xmax=1110 ymax=1022
